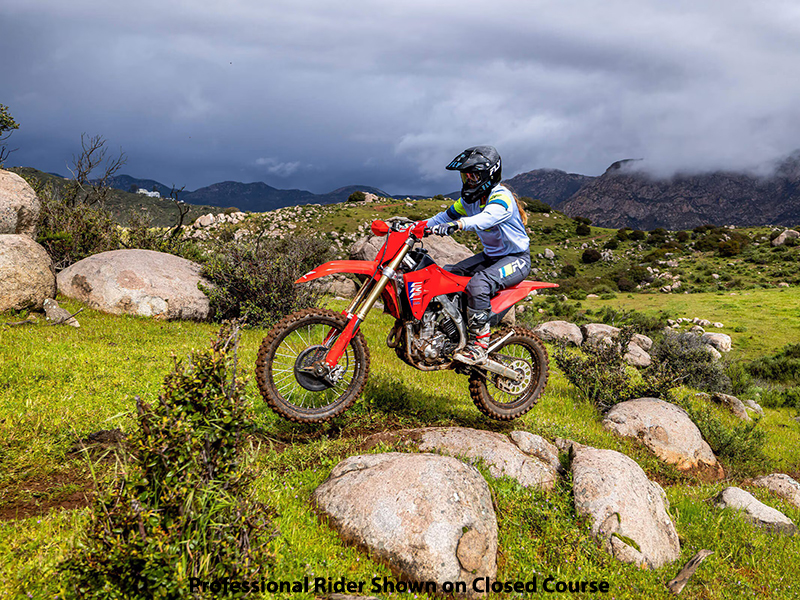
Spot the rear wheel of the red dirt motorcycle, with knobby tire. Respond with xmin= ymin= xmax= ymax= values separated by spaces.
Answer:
xmin=469 ymin=327 xmax=550 ymax=421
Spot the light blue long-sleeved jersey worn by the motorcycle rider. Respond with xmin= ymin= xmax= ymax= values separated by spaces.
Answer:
xmin=428 ymin=185 xmax=531 ymax=256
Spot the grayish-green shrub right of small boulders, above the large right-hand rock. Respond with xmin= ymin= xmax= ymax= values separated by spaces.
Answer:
xmin=650 ymin=333 xmax=731 ymax=392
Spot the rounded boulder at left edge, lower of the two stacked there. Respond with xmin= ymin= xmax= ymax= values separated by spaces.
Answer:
xmin=0 ymin=234 xmax=56 ymax=313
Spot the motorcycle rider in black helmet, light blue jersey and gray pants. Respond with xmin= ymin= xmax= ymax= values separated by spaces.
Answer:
xmin=427 ymin=146 xmax=531 ymax=364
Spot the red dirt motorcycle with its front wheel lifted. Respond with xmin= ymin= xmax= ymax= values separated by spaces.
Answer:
xmin=256 ymin=221 xmax=558 ymax=423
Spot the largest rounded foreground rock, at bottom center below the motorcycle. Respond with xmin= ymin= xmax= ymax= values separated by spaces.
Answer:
xmin=313 ymin=453 xmax=497 ymax=596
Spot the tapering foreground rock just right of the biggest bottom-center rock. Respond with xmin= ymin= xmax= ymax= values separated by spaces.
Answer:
xmin=572 ymin=445 xmax=680 ymax=569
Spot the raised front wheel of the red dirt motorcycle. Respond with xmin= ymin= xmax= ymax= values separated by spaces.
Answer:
xmin=256 ymin=308 xmax=369 ymax=423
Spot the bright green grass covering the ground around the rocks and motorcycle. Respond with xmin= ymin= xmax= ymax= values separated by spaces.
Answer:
xmin=0 ymin=298 xmax=800 ymax=600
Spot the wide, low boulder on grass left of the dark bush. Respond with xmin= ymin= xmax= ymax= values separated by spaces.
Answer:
xmin=58 ymin=250 xmax=211 ymax=319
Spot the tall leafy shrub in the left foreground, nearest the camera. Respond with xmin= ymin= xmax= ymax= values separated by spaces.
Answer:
xmin=62 ymin=327 xmax=276 ymax=599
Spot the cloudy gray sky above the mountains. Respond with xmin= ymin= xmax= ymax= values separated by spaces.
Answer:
xmin=0 ymin=0 xmax=800 ymax=194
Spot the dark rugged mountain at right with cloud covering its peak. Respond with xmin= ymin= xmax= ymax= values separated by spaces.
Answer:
xmin=559 ymin=151 xmax=800 ymax=230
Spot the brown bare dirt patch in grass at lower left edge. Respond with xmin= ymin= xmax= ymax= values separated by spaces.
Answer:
xmin=0 ymin=470 xmax=94 ymax=521
